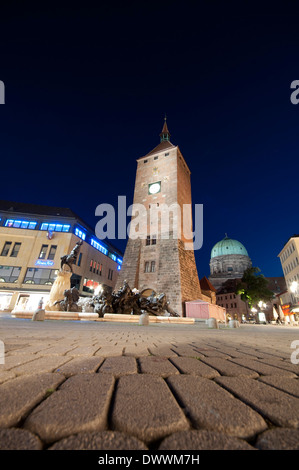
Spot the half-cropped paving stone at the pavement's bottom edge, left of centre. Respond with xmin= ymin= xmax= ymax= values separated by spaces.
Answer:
xmin=49 ymin=431 xmax=148 ymax=451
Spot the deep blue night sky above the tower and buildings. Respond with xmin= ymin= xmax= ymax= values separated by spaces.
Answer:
xmin=0 ymin=1 xmax=299 ymax=277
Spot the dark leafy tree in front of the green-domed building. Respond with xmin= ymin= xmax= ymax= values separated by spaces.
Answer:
xmin=236 ymin=267 xmax=273 ymax=308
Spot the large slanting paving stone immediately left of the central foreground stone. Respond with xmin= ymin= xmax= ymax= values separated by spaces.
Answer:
xmin=24 ymin=374 xmax=114 ymax=443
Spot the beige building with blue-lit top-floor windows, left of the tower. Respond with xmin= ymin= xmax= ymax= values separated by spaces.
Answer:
xmin=0 ymin=201 xmax=122 ymax=311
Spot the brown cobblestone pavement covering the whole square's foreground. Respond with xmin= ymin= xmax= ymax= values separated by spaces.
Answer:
xmin=0 ymin=315 xmax=299 ymax=450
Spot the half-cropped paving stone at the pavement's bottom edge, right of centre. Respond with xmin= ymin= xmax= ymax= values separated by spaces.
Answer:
xmin=159 ymin=430 xmax=255 ymax=450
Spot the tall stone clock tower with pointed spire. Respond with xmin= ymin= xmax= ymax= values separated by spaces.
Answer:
xmin=116 ymin=118 xmax=201 ymax=316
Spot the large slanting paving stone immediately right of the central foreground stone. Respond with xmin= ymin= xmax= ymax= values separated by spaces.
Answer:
xmin=167 ymin=375 xmax=267 ymax=439
